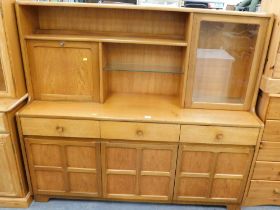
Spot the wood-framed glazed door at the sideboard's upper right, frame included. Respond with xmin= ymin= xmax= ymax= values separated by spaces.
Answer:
xmin=187 ymin=15 xmax=265 ymax=110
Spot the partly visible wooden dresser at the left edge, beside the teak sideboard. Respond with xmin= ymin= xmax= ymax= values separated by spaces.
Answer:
xmin=0 ymin=0 xmax=31 ymax=207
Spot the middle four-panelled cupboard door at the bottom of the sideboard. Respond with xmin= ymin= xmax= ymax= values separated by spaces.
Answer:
xmin=101 ymin=142 xmax=177 ymax=201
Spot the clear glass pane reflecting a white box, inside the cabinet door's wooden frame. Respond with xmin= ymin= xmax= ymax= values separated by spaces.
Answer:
xmin=193 ymin=21 xmax=259 ymax=104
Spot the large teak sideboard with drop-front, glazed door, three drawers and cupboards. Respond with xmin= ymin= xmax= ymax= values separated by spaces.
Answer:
xmin=13 ymin=0 xmax=273 ymax=209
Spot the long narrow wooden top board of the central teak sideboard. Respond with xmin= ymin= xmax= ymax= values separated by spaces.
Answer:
xmin=16 ymin=0 xmax=272 ymax=17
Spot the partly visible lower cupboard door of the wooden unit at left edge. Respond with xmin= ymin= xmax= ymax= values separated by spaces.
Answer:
xmin=0 ymin=134 xmax=22 ymax=197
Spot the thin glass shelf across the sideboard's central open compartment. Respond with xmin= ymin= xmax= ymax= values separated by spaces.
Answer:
xmin=104 ymin=64 xmax=182 ymax=74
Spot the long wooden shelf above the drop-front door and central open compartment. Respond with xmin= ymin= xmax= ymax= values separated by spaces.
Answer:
xmin=25 ymin=34 xmax=188 ymax=47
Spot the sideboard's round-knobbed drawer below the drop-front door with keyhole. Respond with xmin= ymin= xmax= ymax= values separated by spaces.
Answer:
xmin=21 ymin=118 xmax=100 ymax=138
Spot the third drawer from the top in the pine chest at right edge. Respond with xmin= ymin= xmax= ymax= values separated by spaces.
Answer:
xmin=257 ymin=141 xmax=280 ymax=161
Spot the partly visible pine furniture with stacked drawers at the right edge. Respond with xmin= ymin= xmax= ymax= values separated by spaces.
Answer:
xmin=245 ymin=0 xmax=280 ymax=205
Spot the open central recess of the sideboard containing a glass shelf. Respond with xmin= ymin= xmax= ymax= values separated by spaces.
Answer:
xmin=102 ymin=43 xmax=186 ymax=96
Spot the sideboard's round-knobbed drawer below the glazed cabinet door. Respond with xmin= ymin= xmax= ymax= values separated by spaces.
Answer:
xmin=180 ymin=125 xmax=259 ymax=145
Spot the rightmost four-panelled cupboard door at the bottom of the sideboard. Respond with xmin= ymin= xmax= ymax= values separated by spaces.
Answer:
xmin=174 ymin=144 xmax=253 ymax=203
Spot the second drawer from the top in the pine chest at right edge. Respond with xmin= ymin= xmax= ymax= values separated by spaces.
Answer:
xmin=263 ymin=120 xmax=280 ymax=142
